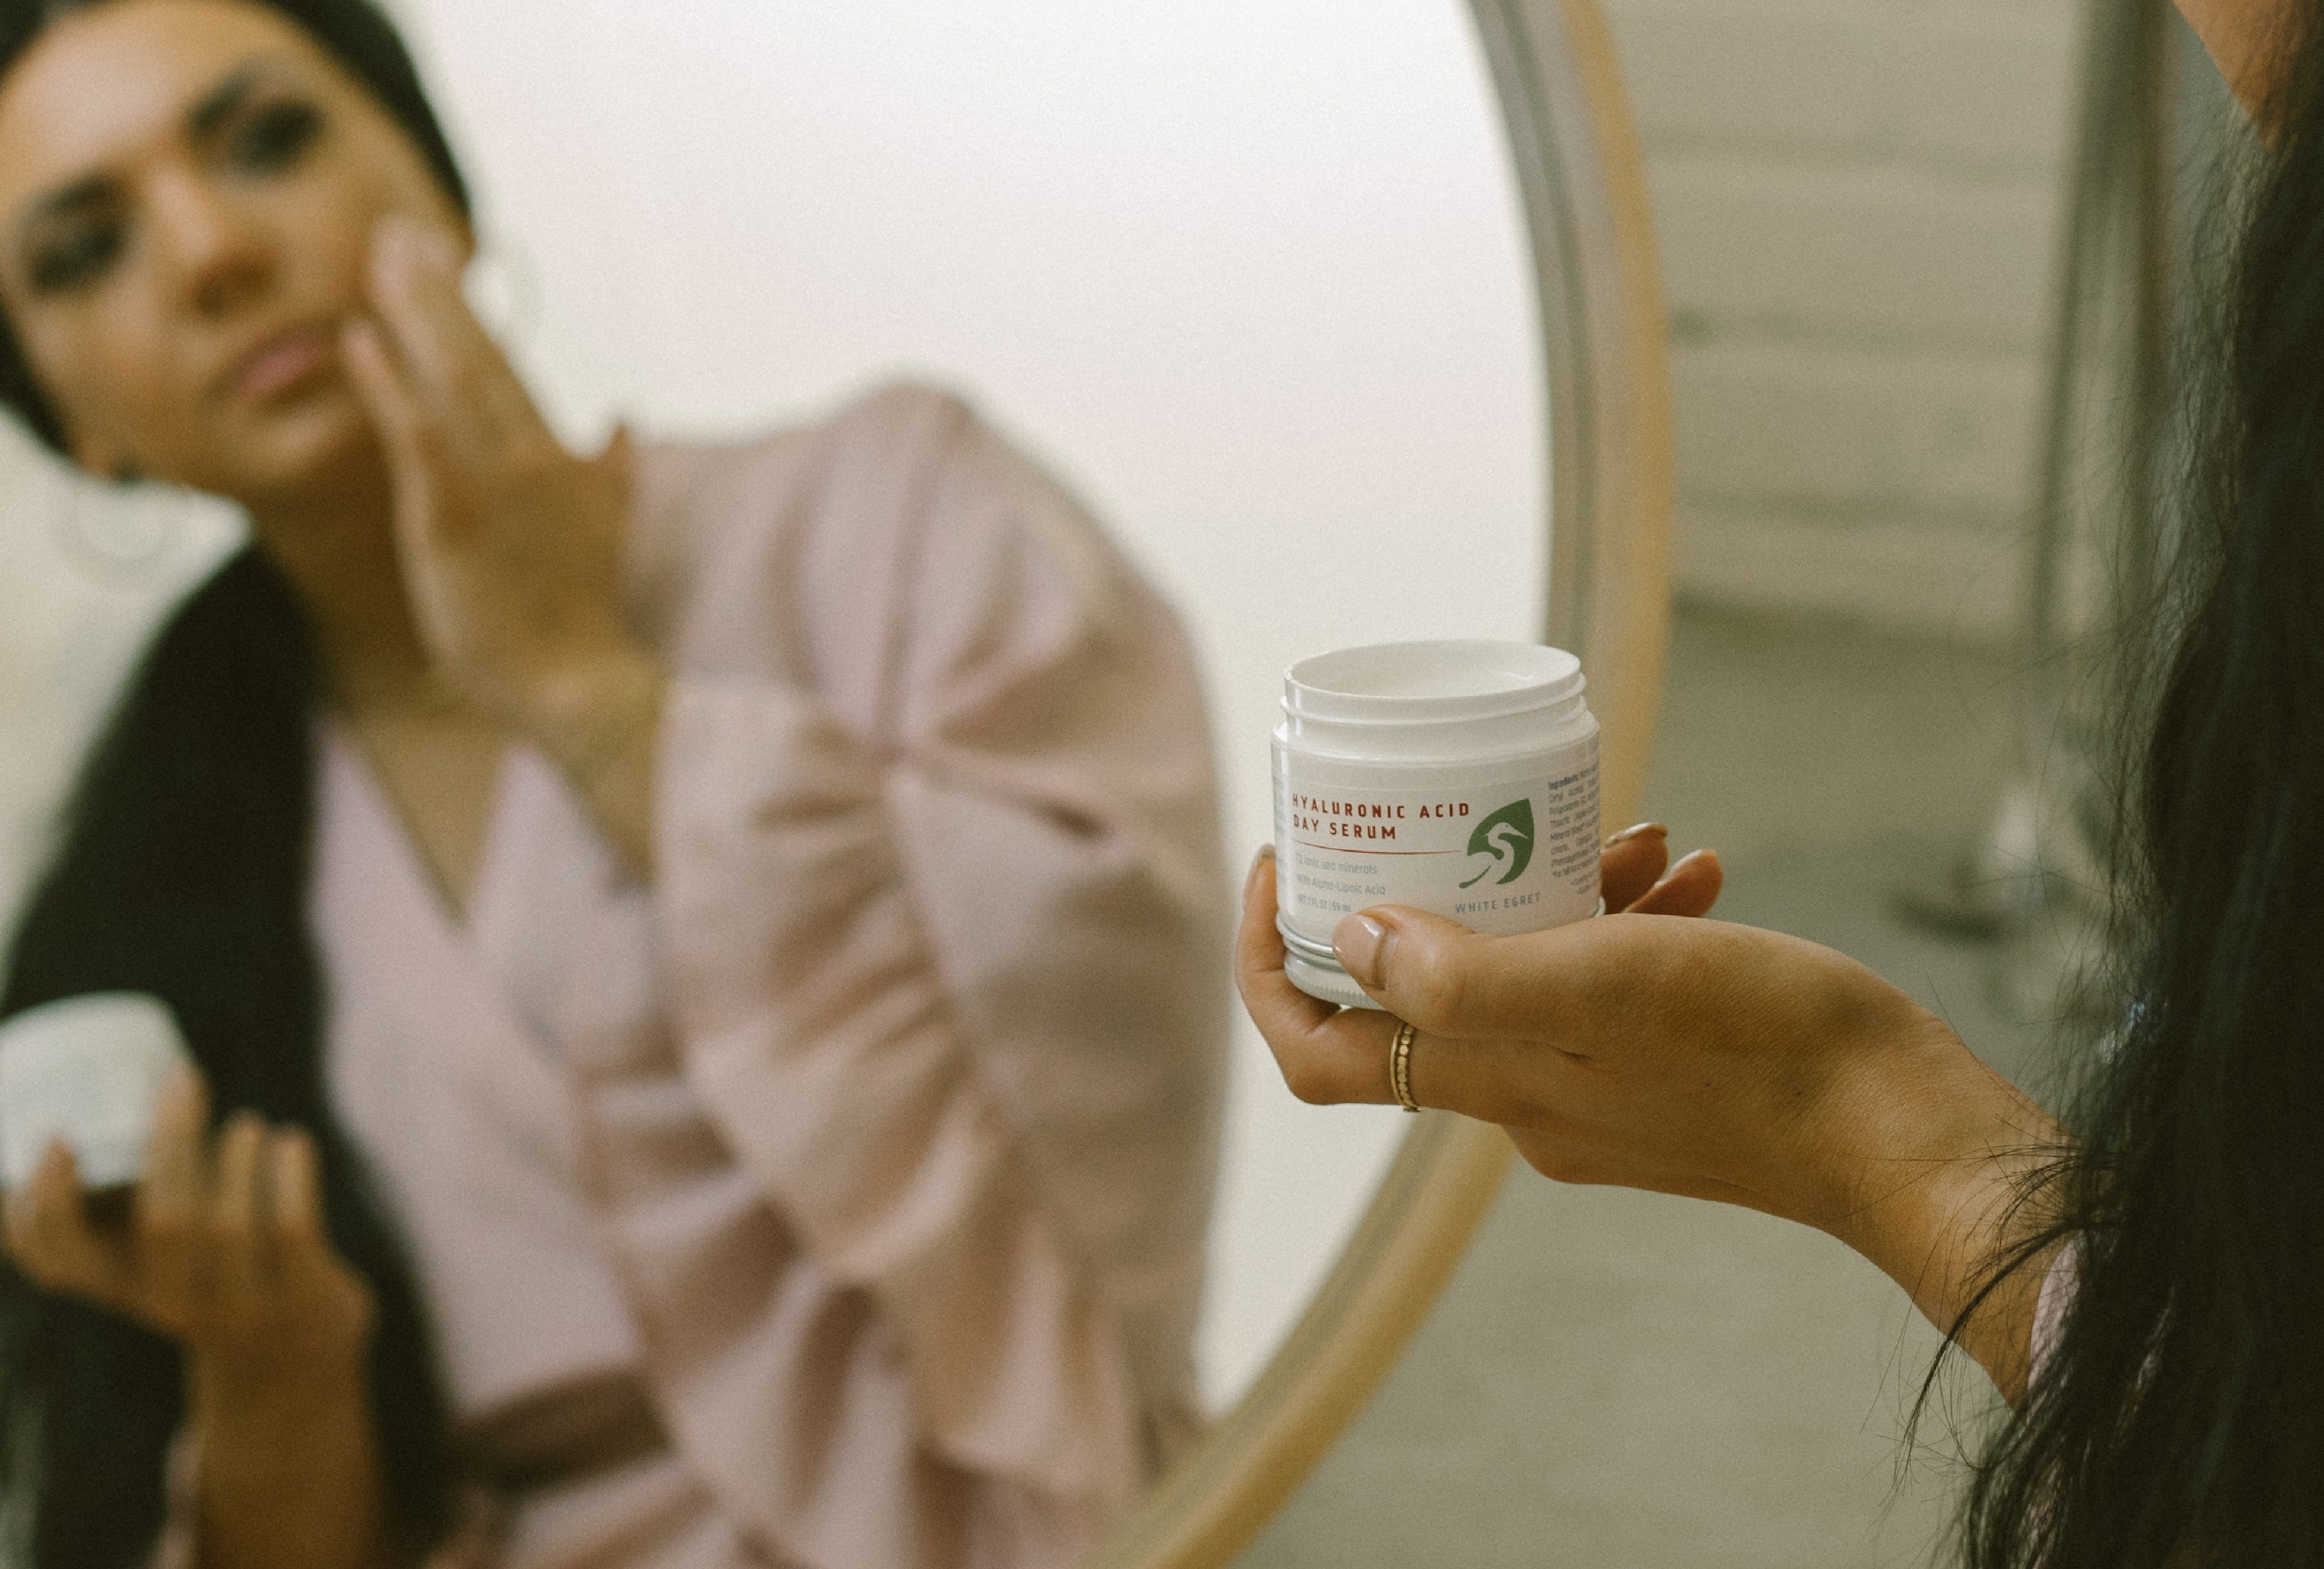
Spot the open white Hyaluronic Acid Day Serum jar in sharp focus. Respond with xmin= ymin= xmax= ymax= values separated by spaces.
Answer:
xmin=1273 ymin=642 xmax=1599 ymax=1009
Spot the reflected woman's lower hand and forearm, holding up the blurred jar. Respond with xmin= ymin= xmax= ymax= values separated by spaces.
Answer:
xmin=7 ymin=1079 xmax=379 ymax=1569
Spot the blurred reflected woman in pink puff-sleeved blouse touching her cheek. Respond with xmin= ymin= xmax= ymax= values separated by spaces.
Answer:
xmin=0 ymin=0 xmax=1225 ymax=1569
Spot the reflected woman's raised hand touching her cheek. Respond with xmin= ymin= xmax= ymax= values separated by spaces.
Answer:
xmin=344 ymin=219 xmax=660 ymax=772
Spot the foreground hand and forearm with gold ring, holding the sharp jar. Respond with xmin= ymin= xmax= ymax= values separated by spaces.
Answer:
xmin=1236 ymin=844 xmax=2064 ymax=1400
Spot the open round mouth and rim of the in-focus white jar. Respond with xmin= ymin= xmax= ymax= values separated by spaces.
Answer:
xmin=1283 ymin=639 xmax=1585 ymax=725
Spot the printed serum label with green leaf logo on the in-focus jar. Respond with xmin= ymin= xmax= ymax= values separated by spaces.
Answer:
xmin=1276 ymin=746 xmax=1599 ymax=941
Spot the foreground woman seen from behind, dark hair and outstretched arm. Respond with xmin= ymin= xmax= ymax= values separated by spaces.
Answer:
xmin=1239 ymin=0 xmax=2324 ymax=1569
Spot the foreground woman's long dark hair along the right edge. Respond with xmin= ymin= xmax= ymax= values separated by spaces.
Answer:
xmin=1966 ymin=7 xmax=2324 ymax=1569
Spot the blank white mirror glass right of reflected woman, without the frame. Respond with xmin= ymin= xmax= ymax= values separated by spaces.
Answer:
xmin=376 ymin=0 xmax=1548 ymax=1409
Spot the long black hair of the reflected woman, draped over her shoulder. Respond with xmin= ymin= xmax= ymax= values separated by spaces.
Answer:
xmin=0 ymin=0 xmax=467 ymax=1569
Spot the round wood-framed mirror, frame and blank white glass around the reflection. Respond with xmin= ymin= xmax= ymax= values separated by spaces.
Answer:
xmin=0 ymin=0 xmax=1669 ymax=1564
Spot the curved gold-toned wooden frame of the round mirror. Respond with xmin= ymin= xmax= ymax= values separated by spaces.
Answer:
xmin=1092 ymin=0 xmax=1676 ymax=1569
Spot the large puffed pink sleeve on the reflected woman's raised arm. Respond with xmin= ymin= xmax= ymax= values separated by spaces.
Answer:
xmin=627 ymin=388 xmax=1232 ymax=1525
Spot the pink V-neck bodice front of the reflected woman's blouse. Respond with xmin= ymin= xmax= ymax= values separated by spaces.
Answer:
xmin=313 ymin=734 xmax=639 ymax=1416
